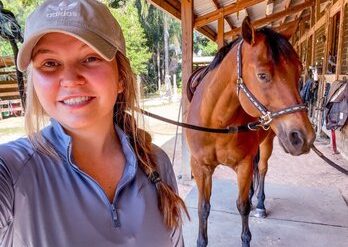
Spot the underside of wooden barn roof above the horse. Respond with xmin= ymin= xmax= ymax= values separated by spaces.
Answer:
xmin=148 ymin=0 xmax=330 ymax=41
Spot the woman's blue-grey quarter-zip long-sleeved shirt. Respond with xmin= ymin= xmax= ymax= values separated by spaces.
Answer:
xmin=0 ymin=120 xmax=183 ymax=247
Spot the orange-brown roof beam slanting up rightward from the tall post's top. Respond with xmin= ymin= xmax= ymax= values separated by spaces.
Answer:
xmin=194 ymin=0 xmax=264 ymax=27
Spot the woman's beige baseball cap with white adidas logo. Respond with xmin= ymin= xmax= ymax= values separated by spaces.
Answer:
xmin=17 ymin=0 xmax=126 ymax=71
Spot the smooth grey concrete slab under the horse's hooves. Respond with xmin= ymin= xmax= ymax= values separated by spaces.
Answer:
xmin=184 ymin=179 xmax=348 ymax=247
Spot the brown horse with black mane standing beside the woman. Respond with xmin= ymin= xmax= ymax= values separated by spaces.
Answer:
xmin=185 ymin=18 xmax=315 ymax=247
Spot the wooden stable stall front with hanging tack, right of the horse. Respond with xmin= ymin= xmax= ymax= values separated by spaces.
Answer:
xmin=292 ymin=0 xmax=348 ymax=157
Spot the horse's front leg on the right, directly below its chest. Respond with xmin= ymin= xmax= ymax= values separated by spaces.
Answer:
xmin=237 ymin=157 xmax=252 ymax=247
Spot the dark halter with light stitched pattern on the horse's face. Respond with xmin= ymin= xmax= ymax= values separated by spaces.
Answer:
xmin=237 ymin=40 xmax=307 ymax=130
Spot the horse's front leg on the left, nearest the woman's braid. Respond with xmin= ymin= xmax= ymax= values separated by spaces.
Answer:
xmin=191 ymin=157 xmax=214 ymax=247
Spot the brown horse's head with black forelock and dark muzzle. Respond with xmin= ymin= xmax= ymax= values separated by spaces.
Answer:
xmin=239 ymin=18 xmax=315 ymax=155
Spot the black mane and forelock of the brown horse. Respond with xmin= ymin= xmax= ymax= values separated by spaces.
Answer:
xmin=197 ymin=27 xmax=300 ymax=82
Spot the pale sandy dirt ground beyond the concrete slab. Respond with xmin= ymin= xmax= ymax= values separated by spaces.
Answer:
xmin=0 ymin=99 xmax=348 ymax=205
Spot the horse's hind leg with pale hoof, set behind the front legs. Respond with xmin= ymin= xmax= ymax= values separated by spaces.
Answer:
xmin=255 ymin=132 xmax=275 ymax=218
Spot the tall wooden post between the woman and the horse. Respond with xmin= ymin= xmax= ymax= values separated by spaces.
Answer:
xmin=181 ymin=0 xmax=193 ymax=180
